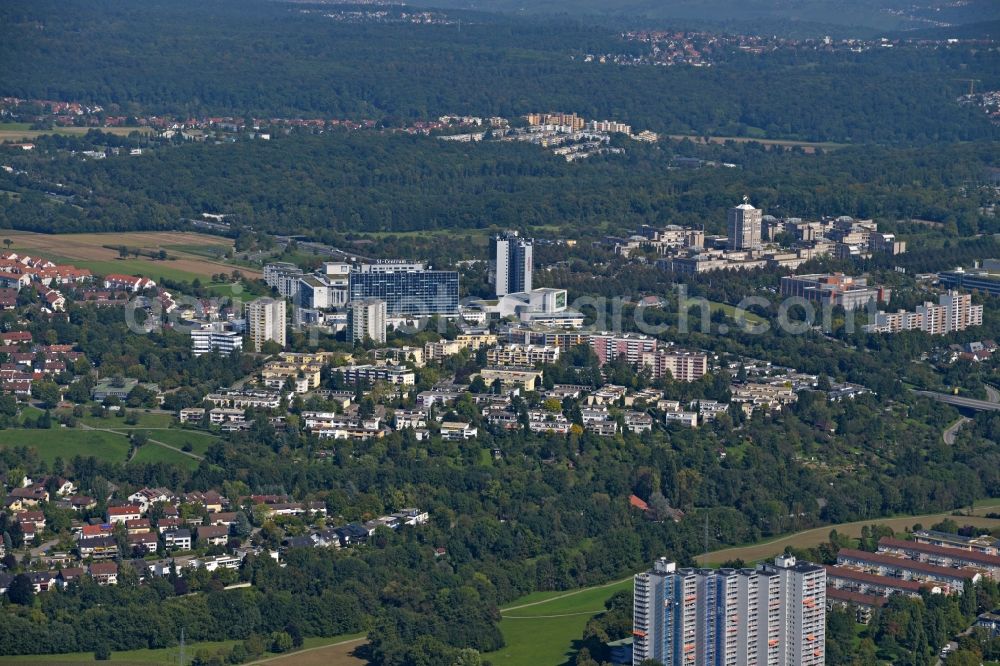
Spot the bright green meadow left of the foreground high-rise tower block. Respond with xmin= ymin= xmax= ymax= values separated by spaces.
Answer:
xmin=485 ymin=578 xmax=632 ymax=666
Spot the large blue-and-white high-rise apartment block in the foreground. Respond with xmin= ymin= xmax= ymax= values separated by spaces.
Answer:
xmin=632 ymin=556 xmax=826 ymax=666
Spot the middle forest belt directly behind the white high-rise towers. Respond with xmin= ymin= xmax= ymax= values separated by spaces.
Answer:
xmin=0 ymin=132 xmax=1000 ymax=238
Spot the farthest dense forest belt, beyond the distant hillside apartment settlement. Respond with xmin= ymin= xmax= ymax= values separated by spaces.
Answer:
xmin=0 ymin=0 xmax=1000 ymax=142
